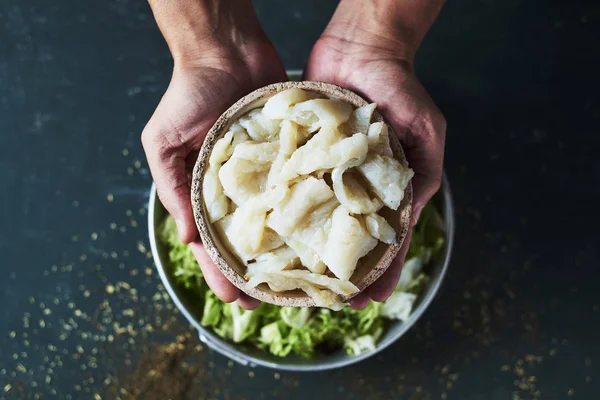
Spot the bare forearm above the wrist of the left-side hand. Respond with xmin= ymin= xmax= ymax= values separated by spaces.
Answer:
xmin=148 ymin=0 xmax=266 ymax=63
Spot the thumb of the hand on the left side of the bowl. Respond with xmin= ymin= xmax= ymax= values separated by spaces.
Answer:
xmin=142 ymin=122 xmax=198 ymax=243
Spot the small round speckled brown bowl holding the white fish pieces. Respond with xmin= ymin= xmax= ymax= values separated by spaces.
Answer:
xmin=191 ymin=81 xmax=412 ymax=307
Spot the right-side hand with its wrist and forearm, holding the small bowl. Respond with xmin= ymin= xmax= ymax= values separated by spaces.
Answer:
xmin=305 ymin=0 xmax=446 ymax=309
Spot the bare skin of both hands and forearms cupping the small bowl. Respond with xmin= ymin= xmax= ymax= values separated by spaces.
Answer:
xmin=142 ymin=0 xmax=446 ymax=309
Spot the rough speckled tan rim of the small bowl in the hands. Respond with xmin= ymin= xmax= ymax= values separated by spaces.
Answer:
xmin=191 ymin=81 xmax=413 ymax=307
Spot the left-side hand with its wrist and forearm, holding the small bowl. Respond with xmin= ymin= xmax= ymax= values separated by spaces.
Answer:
xmin=142 ymin=1 xmax=287 ymax=309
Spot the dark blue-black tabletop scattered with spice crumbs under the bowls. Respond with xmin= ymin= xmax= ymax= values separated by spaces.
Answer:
xmin=0 ymin=0 xmax=600 ymax=400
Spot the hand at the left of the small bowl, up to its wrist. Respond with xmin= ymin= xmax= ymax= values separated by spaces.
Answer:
xmin=142 ymin=32 xmax=287 ymax=309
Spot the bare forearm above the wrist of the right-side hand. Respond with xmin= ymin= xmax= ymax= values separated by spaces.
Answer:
xmin=325 ymin=0 xmax=445 ymax=62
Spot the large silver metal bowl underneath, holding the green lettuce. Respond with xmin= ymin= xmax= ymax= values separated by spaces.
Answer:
xmin=148 ymin=71 xmax=454 ymax=371
